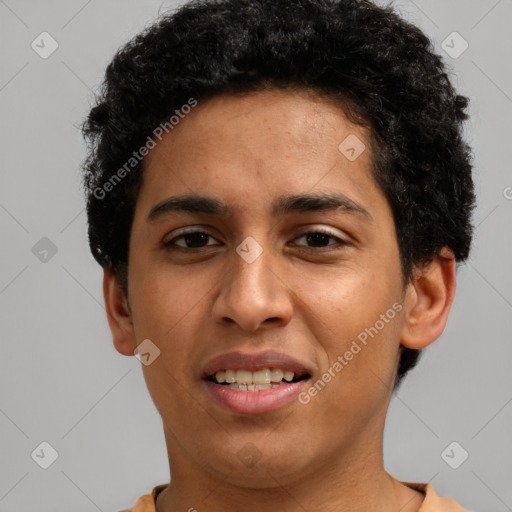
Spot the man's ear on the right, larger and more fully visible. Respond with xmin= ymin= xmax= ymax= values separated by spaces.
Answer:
xmin=401 ymin=247 xmax=456 ymax=349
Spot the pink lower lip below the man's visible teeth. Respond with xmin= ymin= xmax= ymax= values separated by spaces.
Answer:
xmin=203 ymin=379 xmax=308 ymax=414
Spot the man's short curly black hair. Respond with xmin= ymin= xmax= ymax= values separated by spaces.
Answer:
xmin=82 ymin=0 xmax=475 ymax=389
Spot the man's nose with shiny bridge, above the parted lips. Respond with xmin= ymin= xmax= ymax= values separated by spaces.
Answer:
xmin=213 ymin=242 xmax=293 ymax=332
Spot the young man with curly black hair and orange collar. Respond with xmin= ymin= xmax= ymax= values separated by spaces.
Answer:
xmin=84 ymin=0 xmax=475 ymax=512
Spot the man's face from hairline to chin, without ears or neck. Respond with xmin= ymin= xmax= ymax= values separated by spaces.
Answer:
xmin=128 ymin=91 xmax=403 ymax=487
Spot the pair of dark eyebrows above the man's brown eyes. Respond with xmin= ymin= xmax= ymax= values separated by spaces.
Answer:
xmin=147 ymin=193 xmax=373 ymax=222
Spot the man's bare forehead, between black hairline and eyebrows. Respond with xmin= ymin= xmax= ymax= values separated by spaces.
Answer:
xmin=145 ymin=90 xmax=372 ymax=186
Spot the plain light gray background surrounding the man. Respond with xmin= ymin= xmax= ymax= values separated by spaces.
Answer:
xmin=0 ymin=0 xmax=512 ymax=512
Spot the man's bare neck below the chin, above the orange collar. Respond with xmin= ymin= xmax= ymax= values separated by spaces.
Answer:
xmin=156 ymin=420 xmax=424 ymax=512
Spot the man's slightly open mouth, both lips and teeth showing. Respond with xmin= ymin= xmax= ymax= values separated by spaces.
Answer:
xmin=201 ymin=351 xmax=313 ymax=414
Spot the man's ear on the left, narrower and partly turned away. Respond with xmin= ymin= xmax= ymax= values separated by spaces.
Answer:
xmin=103 ymin=269 xmax=137 ymax=356
